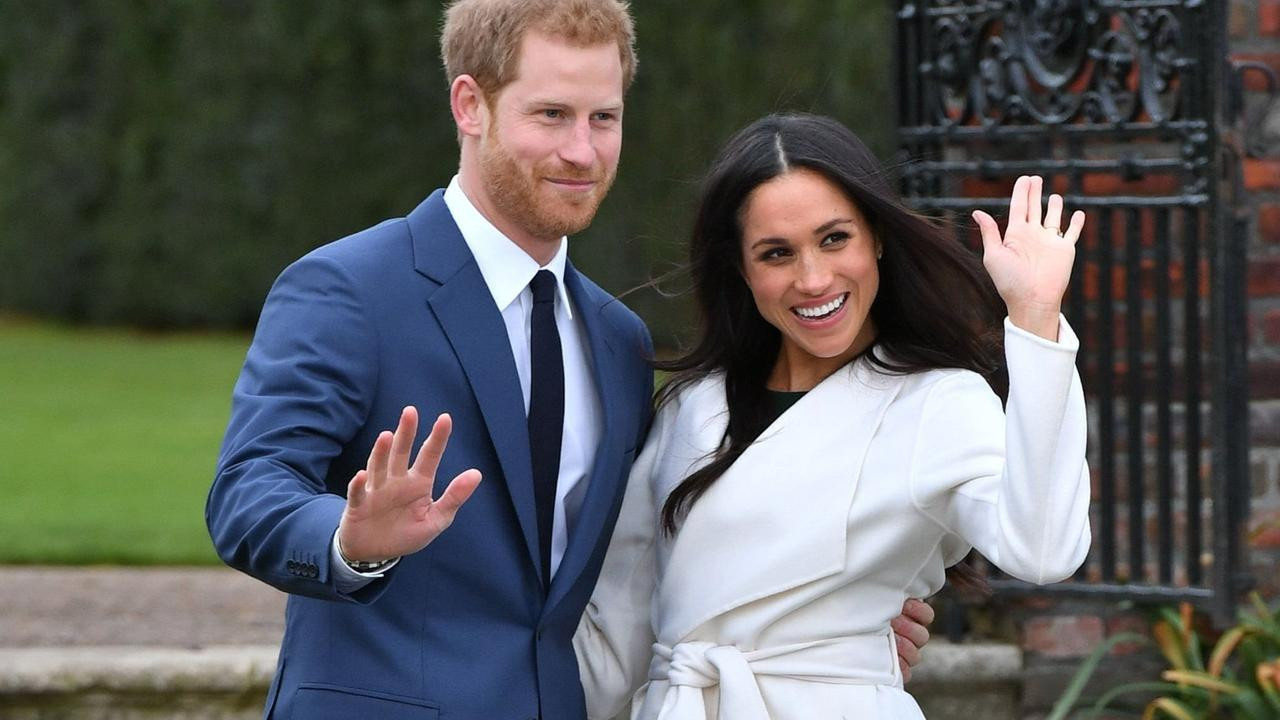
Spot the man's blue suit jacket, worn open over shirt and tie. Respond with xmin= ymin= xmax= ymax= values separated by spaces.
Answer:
xmin=206 ymin=191 xmax=653 ymax=720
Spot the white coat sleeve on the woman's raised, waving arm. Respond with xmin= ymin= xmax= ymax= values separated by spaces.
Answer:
xmin=910 ymin=313 xmax=1091 ymax=584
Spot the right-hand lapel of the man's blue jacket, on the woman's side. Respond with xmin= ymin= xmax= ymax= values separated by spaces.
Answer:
xmin=547 ymin=265 xmax=623 ymax=610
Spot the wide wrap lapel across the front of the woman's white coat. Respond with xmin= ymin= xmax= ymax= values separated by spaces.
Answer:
xmin=657 ymin=361 xmax=902 ymax=643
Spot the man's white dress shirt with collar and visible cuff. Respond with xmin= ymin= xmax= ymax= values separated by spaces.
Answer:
xmin=330 ymin=176 xmax=603 ymax=593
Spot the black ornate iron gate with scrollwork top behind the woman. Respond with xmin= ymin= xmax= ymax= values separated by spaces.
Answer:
xmin=896 ymin=0 xmax=1248 ymax=619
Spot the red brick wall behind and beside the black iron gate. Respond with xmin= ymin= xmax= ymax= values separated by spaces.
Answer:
xmin=969 ymin=0 xmax=1280 ymax=719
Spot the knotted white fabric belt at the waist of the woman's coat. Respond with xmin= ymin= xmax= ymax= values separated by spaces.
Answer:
xmin=649 ymin=632 xmax=902 ymax=720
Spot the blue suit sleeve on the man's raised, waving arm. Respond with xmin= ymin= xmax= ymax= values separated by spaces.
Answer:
xmin=205 ymin=255 xmax=385 ymax=601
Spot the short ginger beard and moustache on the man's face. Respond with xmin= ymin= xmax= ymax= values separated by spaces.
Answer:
xmin=480 ymin=132 xmax=613 ymax=240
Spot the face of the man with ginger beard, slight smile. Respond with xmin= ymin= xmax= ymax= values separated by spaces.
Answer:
xmin=479 ymin=32 xmax=622 ymax=242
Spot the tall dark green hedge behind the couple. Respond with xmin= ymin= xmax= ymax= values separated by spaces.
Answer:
xmin=0 ymin=0 xmax=893 ymax=342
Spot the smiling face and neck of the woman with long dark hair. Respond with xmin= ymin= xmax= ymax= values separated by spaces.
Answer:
xmin=741 ymin=169 xmax=879 ymax=391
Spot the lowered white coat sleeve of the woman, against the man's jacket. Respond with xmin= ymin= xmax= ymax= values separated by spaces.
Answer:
xmin=573 ymin=401 xmax=676 ymax=720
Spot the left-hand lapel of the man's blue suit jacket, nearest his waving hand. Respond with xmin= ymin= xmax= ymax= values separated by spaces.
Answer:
xmin=408 ymin=191 xmax=540 ymax=584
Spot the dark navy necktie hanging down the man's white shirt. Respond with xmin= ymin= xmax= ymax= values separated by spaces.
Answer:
xmin=529 ymin=270 xmax=564 ymax=589
